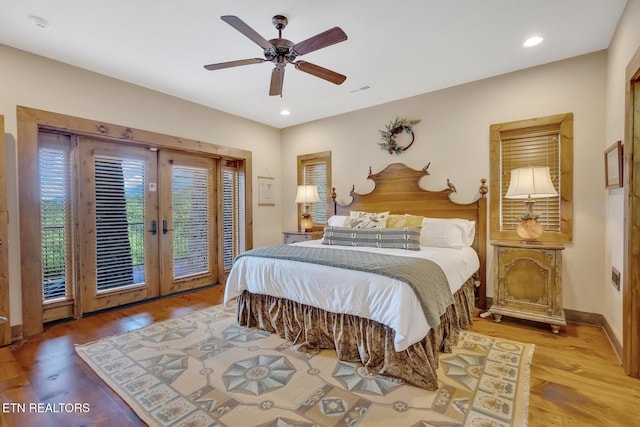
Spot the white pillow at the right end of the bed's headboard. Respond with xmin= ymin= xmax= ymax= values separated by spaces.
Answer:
xmin=420 ymin=218 xmax=475 ymax=249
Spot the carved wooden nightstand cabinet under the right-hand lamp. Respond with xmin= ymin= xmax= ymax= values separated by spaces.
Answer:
xmin=489 ymin=242 xmax=567 ymax=333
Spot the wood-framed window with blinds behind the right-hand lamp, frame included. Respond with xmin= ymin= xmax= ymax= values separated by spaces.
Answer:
xmin=489 ymin=113 xmax=573 ymax=242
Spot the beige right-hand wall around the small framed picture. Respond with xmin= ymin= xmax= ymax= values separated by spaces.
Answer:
xmin=601 ymin=0 xmax=640 ymax=342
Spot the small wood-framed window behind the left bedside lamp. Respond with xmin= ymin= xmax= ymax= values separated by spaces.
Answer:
xmin=298 ymin=151 xmax=331 ymax=228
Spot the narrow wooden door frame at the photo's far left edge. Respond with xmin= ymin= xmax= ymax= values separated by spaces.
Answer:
xmin=0 ymin=116 xmax=11 ymax=346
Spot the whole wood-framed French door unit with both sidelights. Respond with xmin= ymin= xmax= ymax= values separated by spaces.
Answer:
xmin=17 ymin=106 xmax=253 ymax=337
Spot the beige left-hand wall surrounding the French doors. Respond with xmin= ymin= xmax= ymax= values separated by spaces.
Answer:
xmin=0 ymin=45 xmax=282 ymax=325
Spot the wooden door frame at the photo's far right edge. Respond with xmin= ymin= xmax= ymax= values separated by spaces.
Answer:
xmin=622 ymin=49 xmax=640 ymax=378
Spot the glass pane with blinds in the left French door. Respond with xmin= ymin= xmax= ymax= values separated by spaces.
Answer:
xmin=95 ymin=156 xmax=145 ymax=292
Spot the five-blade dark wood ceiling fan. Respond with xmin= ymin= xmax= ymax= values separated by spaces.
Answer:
xmin=204 ymin=15 xmax=347 ymax=96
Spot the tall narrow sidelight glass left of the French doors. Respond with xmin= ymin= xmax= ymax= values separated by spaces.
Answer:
xmin=39 ymin=147 xmax=69 ymax=302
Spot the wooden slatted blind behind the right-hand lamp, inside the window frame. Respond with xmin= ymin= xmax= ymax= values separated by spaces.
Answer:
xmin=500 ymin=125 xmax=561 ymax=232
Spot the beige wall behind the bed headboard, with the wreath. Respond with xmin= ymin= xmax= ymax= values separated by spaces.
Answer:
xmin=282 ymin=52 xmax=607 ymax=313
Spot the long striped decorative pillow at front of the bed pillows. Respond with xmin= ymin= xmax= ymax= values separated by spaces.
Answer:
xmin=322 ymin=227 xmax=420 ymax=251
